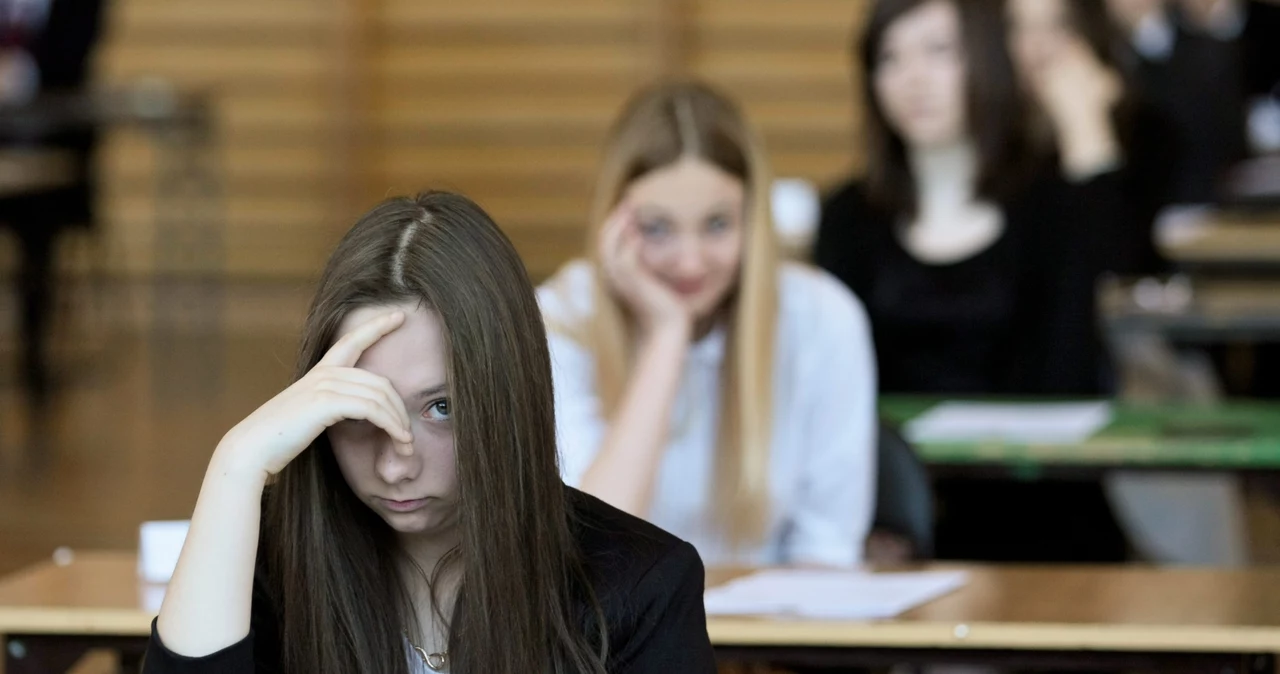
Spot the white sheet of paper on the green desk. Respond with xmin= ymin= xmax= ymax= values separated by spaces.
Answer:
xmin=902 ymin=402 xmax=1112 ymax=445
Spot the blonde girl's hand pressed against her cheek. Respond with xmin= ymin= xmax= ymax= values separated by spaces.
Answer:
xmin=598 ymin=202 xmax=692 ymax=334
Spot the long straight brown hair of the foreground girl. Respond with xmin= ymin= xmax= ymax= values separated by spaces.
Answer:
xmin=264 ymin=192 xmax=607 ymax=674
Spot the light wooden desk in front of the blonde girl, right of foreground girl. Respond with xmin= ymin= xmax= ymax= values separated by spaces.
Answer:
xmin=708 ymin=565 xmax=1280 ymax=673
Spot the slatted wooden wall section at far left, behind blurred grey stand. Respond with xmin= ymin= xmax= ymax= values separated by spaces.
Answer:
xmin=88 ymin=0 xmax=346 ymax=276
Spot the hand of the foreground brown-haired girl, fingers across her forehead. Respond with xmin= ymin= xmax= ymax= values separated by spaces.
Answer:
xmin=207 ymin=311 xmax=413 ymax=478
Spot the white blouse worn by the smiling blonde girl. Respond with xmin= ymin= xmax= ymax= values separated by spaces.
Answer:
xmin=538 ymin=261 xmax=877 ymax=567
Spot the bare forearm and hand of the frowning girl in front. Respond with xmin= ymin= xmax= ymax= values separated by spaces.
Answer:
xmin=156 ymin=312 xmax=413 ymax=657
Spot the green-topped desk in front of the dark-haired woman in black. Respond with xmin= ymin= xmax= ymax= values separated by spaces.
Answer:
xmin=879 ymin=395 xmax=1280 ymax=478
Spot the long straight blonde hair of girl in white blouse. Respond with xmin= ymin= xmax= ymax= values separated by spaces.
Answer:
xmin=553 ymin=83 xmax=777 ymax=545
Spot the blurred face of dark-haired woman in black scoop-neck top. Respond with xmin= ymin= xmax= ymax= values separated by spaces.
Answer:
xmin=872 ymin=0 xmax=968 ymax=148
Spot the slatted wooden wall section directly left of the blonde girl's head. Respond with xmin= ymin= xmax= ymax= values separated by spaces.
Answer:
xmin=372 ymin=0 xmax=654 ymax=278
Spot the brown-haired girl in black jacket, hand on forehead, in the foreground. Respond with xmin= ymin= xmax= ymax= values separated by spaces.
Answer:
xmin=145 ymin=193 xmax=714 ymax=674
